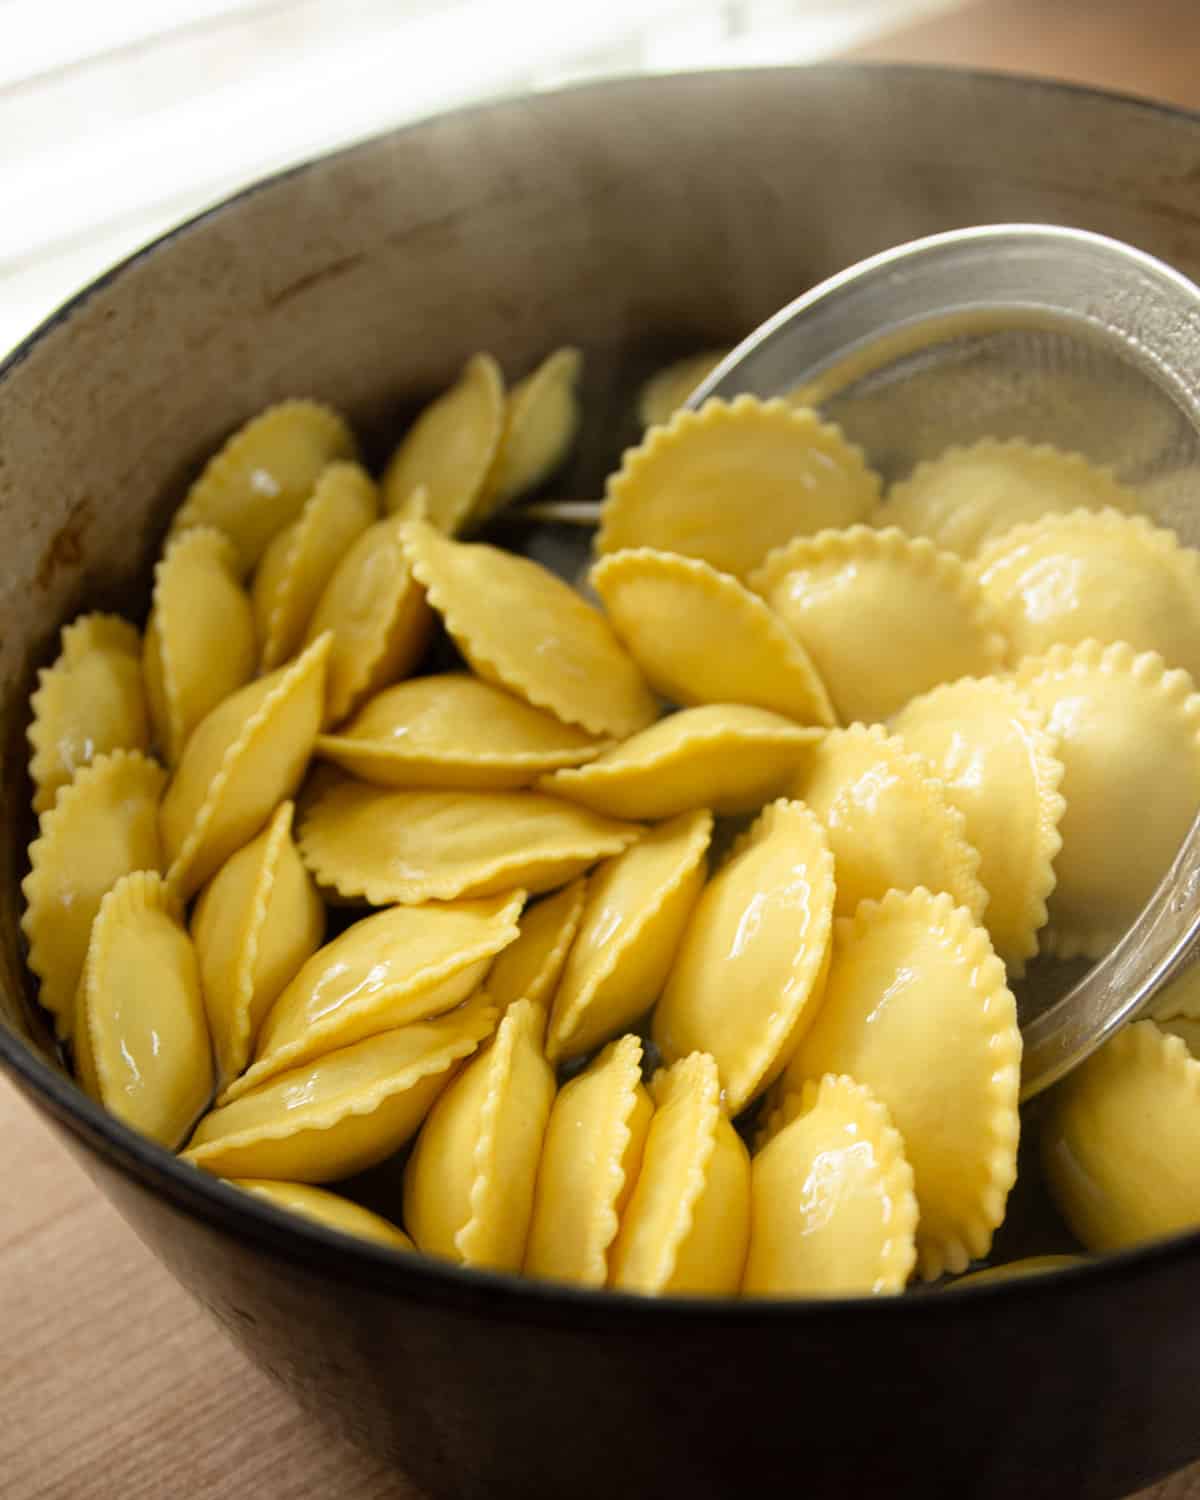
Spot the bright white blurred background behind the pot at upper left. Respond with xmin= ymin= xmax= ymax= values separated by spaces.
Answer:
xmin=0 ymin=0 xmax=960 ymax=354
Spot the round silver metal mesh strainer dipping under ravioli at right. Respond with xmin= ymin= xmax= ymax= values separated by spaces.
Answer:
xmin=689 ymin=225 xmax=1200 ymax=1098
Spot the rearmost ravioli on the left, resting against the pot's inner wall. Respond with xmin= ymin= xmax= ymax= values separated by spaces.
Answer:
xmin=171 ymin=401 xmax=357 ymax=573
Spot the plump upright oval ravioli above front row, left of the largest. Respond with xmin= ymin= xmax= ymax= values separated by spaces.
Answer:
xmin=653 ymin=801 xmax=834 ymax=1115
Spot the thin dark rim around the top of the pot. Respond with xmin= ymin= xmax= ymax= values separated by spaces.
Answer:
xmin=0 ymin=62 xmax=1200 ymax=1334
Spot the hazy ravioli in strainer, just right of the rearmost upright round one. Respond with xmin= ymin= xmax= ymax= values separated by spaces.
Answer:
xmin=873 ymin=438 xmax=1139 ymax=558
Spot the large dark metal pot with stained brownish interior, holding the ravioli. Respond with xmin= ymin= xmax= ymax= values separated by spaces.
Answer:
xmin=0 ymin=68 xmax=1200 ymax=1500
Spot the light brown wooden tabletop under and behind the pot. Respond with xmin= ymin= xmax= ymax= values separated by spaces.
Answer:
xmin=0 ymin=0 xmax=1200 ymax=1500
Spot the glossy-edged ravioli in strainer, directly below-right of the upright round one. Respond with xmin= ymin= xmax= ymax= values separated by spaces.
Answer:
xmin=750 ymin=527 xmax=1005 ymax=723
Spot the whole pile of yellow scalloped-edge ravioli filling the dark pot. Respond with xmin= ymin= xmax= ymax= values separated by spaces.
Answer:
xmin=24 ymin=337 xmax=1200 ymax=1296
